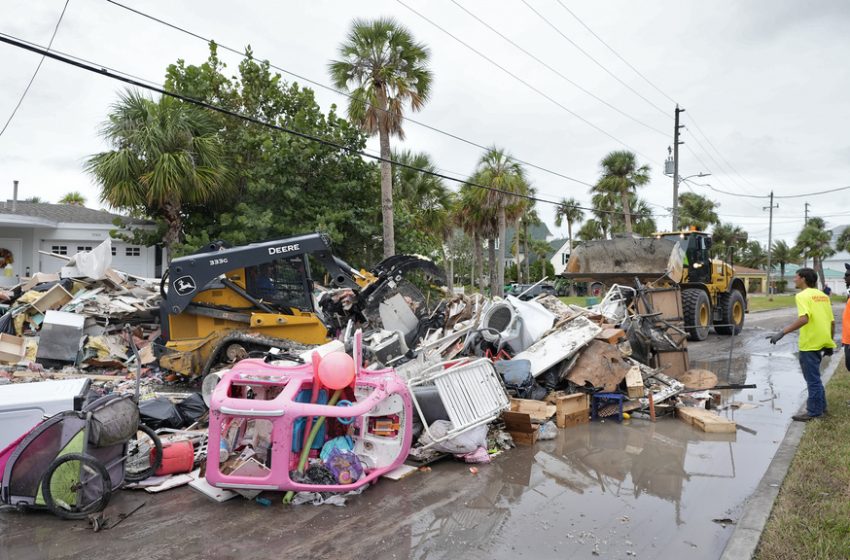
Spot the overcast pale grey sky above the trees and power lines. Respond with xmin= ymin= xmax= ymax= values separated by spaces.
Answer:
xmin=0 ymin=0 xmax=850 ymax=242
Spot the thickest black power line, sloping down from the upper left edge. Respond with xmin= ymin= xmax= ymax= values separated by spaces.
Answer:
xmin=0 ymin=32 xmax=644 ymax=220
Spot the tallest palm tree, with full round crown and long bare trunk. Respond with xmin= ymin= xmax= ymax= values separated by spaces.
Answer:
xmin=329 ymin=18 xmax=432 ymax=257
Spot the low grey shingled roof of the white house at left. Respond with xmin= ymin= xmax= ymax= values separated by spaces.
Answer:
xmin=0 ymin=200 xmax=153 ymax=226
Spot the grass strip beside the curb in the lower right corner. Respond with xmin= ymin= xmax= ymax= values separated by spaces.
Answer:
xmin=754 ymin=363 xmax=850 ymax=560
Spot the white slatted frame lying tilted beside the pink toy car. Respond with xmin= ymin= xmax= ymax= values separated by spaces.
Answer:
xmin=407 ymin=358 xmax=510 ymax=447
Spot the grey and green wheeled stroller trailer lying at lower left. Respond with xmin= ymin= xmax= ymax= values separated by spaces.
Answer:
xmin=0 ymin=325 xmax=162 ymax=519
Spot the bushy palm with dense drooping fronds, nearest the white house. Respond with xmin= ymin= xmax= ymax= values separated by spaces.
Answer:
xmin=86 ymin=91 xmax=229 ymax=259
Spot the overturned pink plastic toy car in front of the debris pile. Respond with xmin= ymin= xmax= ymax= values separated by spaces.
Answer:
xmin=206 ymin=359 xmax=412 ymax=492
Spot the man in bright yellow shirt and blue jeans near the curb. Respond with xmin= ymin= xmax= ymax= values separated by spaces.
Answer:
xmin=768 ymin=268 xmax=835 ymax=422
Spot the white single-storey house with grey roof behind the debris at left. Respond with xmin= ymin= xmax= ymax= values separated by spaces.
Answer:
xmin=0 ymin=200 xmax=164 ymax=286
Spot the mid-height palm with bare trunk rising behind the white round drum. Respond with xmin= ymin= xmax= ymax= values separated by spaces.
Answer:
xmin=474 ymin=147 xmax=529 ymax=296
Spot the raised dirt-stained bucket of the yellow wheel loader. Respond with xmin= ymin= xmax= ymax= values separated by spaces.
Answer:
xmin=563 ymin=237 xmax=685 ymax=285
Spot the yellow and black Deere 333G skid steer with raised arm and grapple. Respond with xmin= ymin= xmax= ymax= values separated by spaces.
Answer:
xmin=155 ymin=233 xmax=445 ymax=377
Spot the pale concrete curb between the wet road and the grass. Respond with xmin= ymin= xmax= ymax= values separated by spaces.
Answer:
xmin=720 ymin=352 xmax=844 ymax=560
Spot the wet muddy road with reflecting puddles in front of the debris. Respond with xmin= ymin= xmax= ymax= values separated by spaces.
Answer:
xmin=0 ymin=309 xmax=840 ymax=560
